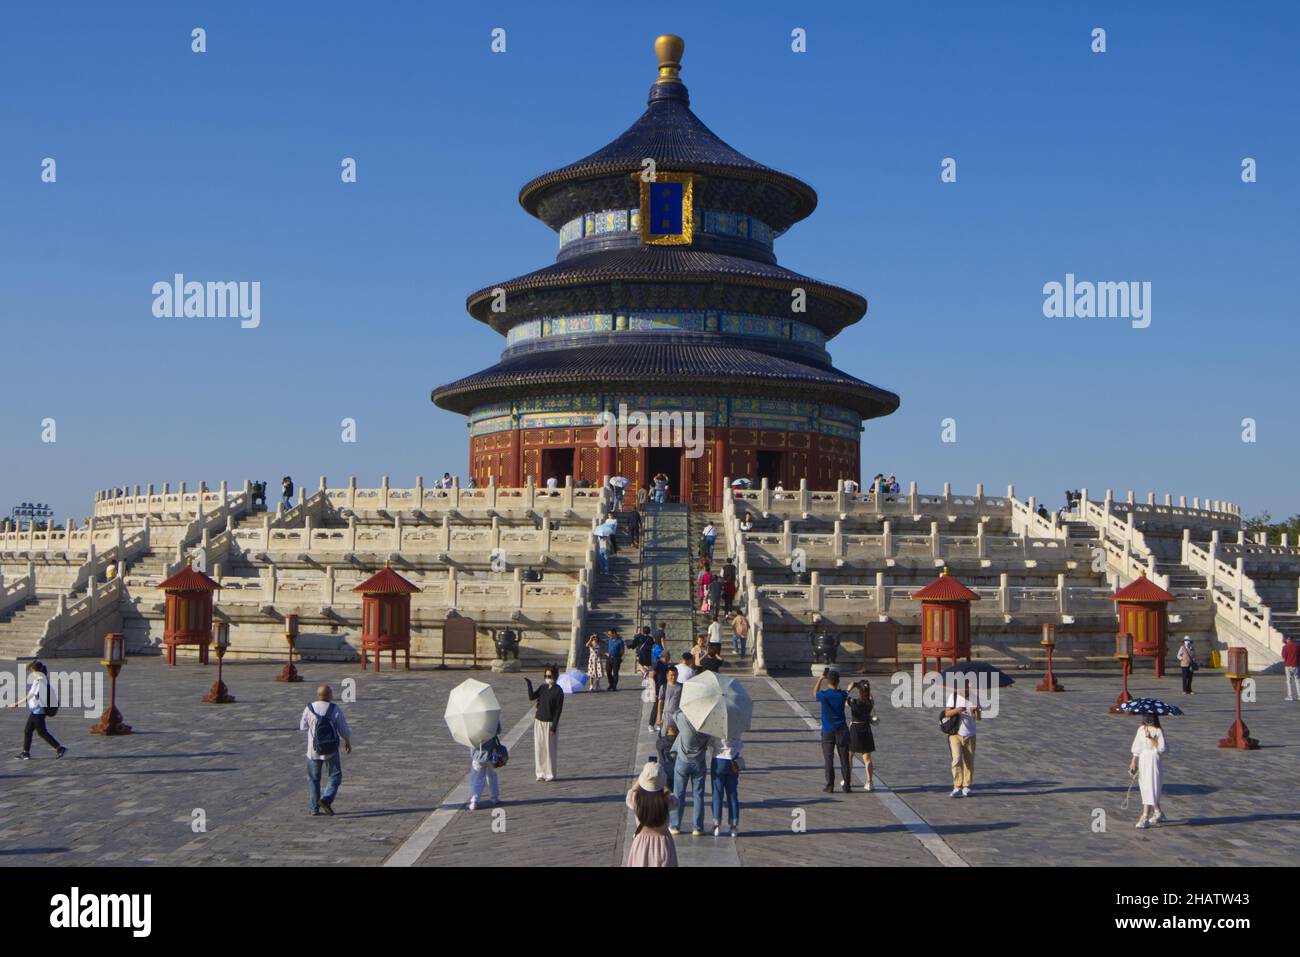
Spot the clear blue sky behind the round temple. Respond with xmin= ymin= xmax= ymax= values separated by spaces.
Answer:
xmin=0 ymin=0 xmax=1300 ymax=518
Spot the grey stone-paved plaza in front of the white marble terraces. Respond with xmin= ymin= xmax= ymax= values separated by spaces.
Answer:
xmin=0 ymin=658 xmax=1300 ymax=867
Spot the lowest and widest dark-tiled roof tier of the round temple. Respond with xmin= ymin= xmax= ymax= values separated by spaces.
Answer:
xmin=432 ymin=342 xmax=898 ymax=419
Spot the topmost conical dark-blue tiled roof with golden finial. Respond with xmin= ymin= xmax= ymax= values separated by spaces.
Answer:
xmin=519 ymin=36 xmax=816 ymax=233
